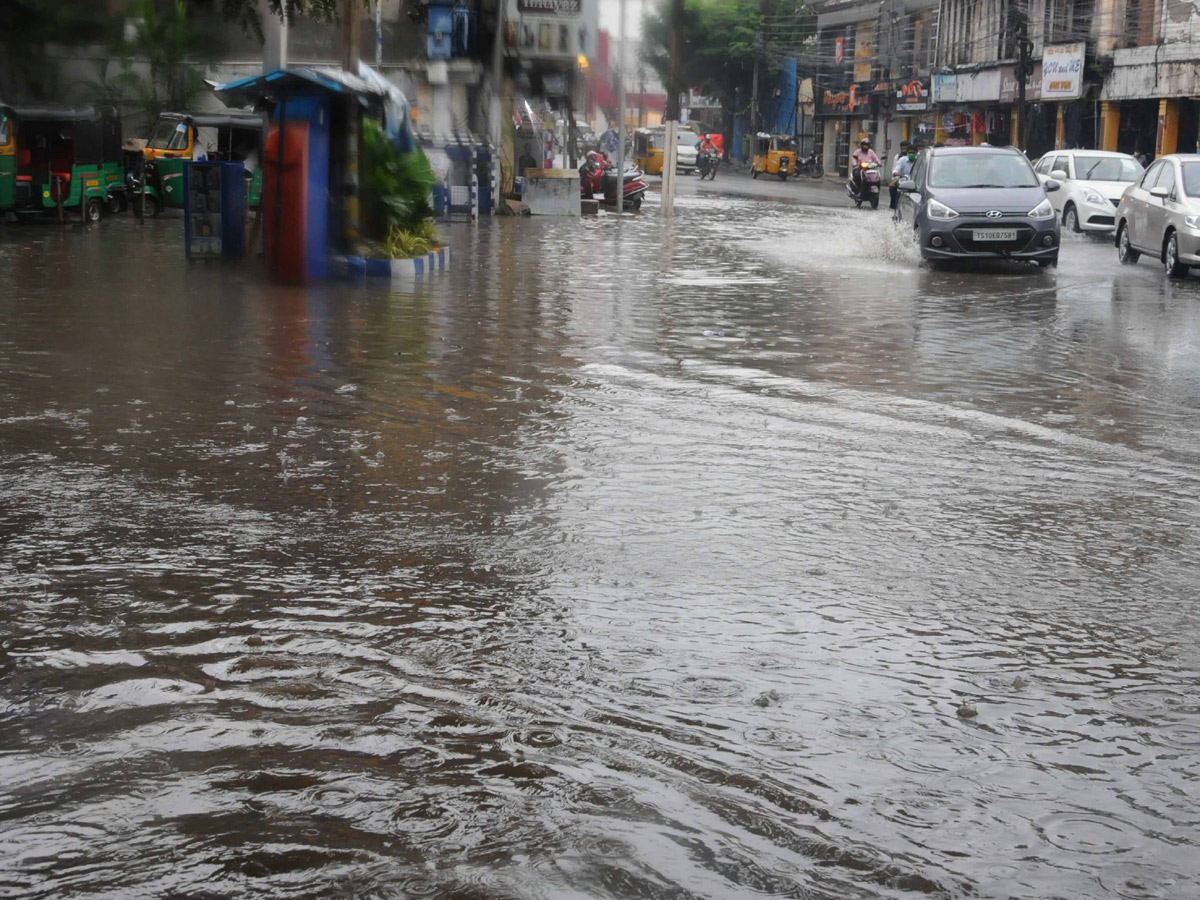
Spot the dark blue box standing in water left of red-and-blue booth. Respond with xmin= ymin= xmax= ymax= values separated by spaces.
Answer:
xmin=184 ymin=162 xmax=246 ymax=259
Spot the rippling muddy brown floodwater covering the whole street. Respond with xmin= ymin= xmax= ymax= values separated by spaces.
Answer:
xmin=0 ymin=196 xmax=1200 ymax=900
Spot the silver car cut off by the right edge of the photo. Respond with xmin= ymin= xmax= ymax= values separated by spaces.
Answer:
xmin=1116 ymin=154 xmax=1200 ymax=278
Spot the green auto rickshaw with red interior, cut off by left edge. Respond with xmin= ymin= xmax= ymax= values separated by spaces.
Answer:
xmin=0 ymin=103 xmax=125 ymax=222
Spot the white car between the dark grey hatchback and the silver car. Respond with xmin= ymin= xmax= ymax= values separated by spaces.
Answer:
xmin=1033 ymin=150 xmax=1142 ymax=234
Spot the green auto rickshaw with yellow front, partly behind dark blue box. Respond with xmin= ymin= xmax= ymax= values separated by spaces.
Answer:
xmin=131 ymin=113 xmax=263 ymax=215
